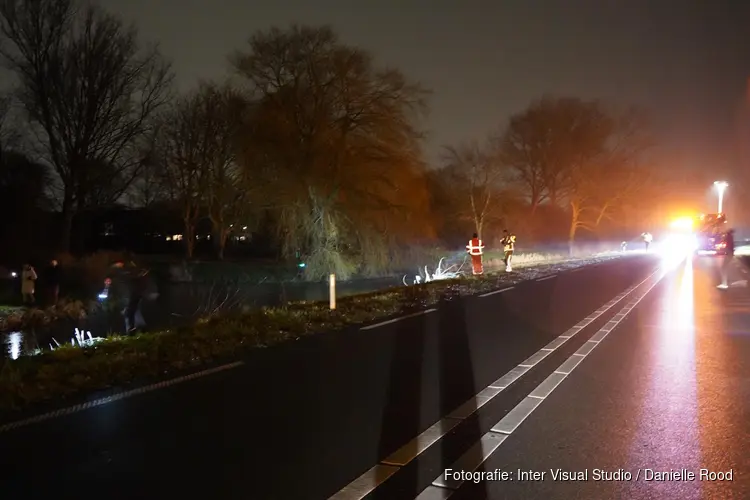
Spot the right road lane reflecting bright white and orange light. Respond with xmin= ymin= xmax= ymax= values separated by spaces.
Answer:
xmin=419 ymin=254 xmax=750 ymax=500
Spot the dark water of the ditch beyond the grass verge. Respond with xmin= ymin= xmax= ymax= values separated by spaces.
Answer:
xmin=0 ymin=277 xmax=402 ymax=359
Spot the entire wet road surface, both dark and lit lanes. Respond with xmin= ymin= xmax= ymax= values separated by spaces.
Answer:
xmin=0 ymin=256 xmax=750 ymax=499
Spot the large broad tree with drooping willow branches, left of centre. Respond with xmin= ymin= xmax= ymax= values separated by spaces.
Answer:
xmin=233 ymin=26 xmax=429 ymax=279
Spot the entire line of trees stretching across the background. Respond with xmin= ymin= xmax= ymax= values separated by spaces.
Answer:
xmin=0 ymin=0 xmax=654 ymax=278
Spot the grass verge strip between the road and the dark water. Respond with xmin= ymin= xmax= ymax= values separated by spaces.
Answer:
xmin=0 ymin=254 xmax=624 ymax=411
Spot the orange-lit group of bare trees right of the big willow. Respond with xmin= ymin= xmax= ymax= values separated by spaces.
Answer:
xmin=441 ymin=98 xmax=654 ymax=246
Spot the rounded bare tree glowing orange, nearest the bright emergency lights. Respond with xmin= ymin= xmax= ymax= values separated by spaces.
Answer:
xmin=502 ymin=98 xmax=649 ymax=251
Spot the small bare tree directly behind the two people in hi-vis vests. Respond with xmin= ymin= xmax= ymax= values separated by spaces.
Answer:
xmin=443 ymin=142 xmax=507 ymax=237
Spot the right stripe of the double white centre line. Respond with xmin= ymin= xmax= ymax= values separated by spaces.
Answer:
xmin=417 ymin=269 xmax=667 ymax=498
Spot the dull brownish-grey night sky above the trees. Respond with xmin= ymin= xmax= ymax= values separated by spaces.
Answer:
xmin=101 ymin=0 xmax=750 ymax=184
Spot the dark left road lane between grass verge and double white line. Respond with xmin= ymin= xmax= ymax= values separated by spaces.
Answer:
xmin=0 ymin=256 xmax=688 ymax=500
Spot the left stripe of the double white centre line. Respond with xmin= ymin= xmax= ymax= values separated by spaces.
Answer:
xmin=329 ymin=264 xmax=659 ymax=500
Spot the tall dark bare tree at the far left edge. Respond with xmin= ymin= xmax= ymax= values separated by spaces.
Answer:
xmin=0 ymin=0 xmax=171 ymax=250
